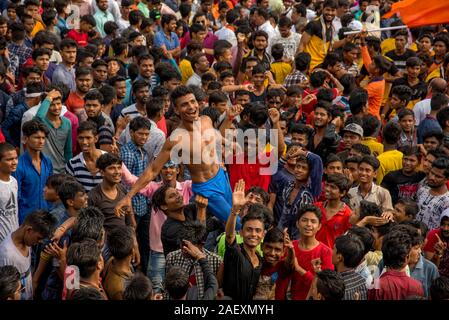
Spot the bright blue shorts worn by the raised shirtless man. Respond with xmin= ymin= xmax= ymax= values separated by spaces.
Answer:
xmin=192 ymin=167 xmax=240 ymax=229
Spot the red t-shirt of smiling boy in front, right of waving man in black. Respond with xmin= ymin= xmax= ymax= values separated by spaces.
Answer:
xmin=291 ymin=240 xmax=334 ymax=300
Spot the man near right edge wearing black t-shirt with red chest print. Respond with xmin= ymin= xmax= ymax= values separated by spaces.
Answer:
xmin=381 ymin=146 xmax=426 ymax=204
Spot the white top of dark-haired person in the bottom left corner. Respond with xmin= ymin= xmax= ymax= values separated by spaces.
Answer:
xmin=0 ymin=234 xmax=33 ymax=300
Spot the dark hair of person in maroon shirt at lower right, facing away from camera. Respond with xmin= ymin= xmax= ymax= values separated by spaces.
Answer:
xmin=382 ymin=230 xmax=412 ymax=269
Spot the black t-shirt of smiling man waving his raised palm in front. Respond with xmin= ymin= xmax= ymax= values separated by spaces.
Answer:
xmin=223 ymin=240 xmax=262 ymax=301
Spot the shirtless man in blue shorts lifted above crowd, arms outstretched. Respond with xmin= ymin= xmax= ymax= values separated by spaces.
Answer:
xmin=116 ymin=86 xmax=283 ymax=222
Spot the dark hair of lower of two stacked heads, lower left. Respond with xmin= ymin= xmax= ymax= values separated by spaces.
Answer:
xmin=67 ymin=239 xmax=101 ymax=278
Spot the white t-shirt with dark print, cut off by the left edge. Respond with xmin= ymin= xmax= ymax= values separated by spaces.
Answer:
xmin=0 ymin=177 xmax=19 ymax=242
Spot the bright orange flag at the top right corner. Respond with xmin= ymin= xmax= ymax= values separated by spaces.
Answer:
xmin=384 ymin=0 xmax=449 ymax=28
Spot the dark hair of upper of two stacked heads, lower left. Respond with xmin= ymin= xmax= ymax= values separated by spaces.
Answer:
xmin=72 ymin=206 xmax=104 ymax=242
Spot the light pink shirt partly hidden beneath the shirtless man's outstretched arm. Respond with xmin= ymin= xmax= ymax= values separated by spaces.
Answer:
xmin=122 ymin=165 xmax=193 ymax=252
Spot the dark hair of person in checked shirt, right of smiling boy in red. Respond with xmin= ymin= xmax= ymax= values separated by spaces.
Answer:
xmin=335 ymin=235 xmax=365 ymax=269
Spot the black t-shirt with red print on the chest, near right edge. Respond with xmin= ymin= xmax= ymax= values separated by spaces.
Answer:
xmin=382 ymin=170 xmax=426 ymax=204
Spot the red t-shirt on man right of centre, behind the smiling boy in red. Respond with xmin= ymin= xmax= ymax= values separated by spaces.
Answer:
xmin=315 ymin=202 xmax=352 ymax=249
